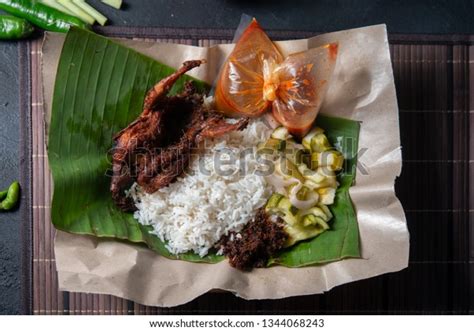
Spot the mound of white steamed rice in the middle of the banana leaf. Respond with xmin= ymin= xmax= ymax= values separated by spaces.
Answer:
xmin=130 ymin=120 xmax=272 ymax=256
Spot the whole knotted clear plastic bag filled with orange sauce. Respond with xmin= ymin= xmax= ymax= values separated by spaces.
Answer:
xmin=215 ymin=19 xmax=338 ymax=136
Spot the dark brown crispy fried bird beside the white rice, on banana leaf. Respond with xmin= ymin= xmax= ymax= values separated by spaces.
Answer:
xmin=110 ymin=60 xmax=248 ymax=211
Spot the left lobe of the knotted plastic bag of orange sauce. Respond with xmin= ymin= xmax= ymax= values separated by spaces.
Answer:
xmin=215 ymin=19 xmax=283 ymax=117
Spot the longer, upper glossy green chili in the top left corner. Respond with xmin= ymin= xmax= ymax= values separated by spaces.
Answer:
xmin=0 ymin=0 xmax=89 ymax=32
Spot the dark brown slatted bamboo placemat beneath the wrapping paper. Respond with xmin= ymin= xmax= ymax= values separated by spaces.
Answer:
xmin=21 ymin=27 xmax=474 ymax=314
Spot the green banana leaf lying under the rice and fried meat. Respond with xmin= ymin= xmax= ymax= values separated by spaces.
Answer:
xmin=48 ymin=28 xmax=359 ymax=267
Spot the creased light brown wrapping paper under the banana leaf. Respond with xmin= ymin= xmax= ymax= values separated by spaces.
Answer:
xmin=43 ymin=25 xmax=409 ymax=306
